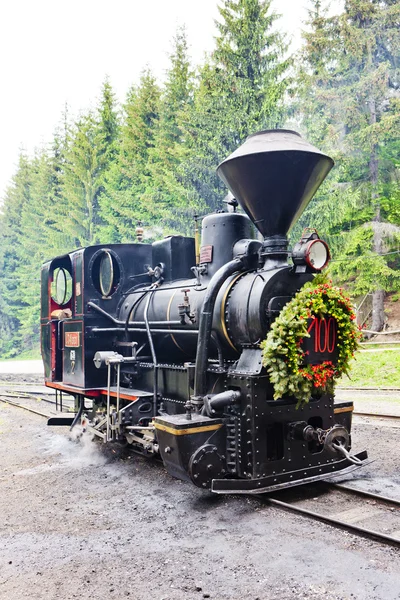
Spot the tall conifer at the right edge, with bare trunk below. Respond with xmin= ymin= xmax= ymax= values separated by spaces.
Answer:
xmin=296 ymin=0 xmax=400 ymax=331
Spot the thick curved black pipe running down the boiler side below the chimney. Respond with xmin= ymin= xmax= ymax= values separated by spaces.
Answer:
xmin=193 ymin=258 xmax=244 ymax=399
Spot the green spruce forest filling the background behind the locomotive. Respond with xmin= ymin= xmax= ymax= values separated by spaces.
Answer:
xmin=0 ymin=0 xmax=400 ymax=358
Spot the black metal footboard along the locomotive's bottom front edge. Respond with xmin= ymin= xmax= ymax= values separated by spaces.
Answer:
xmin=211 ymin=450 xmax=370 ymax=494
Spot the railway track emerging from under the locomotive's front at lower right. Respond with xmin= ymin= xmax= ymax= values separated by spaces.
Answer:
xmin=264 ymin=482 xmax=400 ymax=548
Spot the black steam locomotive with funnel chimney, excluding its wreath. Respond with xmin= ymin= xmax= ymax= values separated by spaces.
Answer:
xmin=41 ymin=130 xmax=367 ymax=493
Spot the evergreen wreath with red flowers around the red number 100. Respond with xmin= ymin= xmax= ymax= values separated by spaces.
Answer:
xmin=261 ymin=274 xmax=362 ymax=407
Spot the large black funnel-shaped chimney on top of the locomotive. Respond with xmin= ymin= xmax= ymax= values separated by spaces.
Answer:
xmin=217 ymin=129 xmax=334 ymax=238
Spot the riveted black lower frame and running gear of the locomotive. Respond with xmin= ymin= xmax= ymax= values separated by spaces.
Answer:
xmin=66 ymin=350 xmax=366 ymax=493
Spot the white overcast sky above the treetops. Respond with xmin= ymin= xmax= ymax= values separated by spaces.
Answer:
xmin=0 ymin=0 xmax=340 ymax=201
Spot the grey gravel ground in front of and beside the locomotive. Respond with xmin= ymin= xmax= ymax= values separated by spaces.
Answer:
xmin=0 ymin=376 xmax=400 ymax=600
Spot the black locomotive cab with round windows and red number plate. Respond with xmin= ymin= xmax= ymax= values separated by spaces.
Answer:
xmin=41 ymin=244 xmax=151 ymax=391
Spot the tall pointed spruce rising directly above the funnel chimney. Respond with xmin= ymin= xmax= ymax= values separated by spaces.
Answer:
xmin=213 ymin=0 xmax=289 ymax=135
